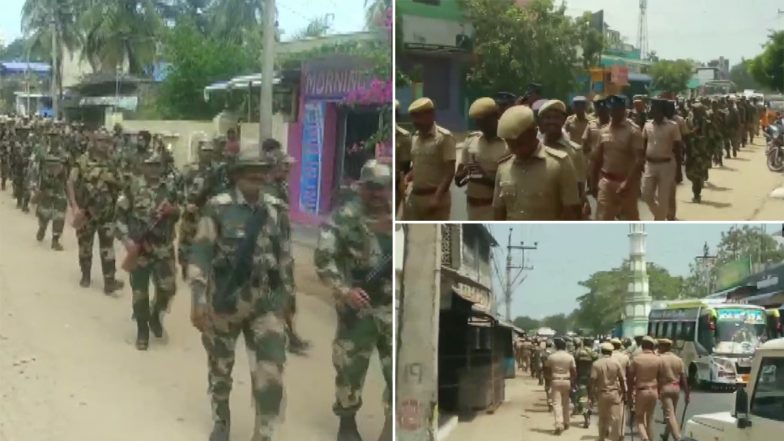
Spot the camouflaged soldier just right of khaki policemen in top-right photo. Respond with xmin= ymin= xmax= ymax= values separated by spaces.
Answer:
xmin=686 ymin=103 xmax=714 ymax=203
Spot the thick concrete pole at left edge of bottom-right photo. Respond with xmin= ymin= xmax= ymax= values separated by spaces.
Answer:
xmin=394 ymin=224 xmax=442 ymax=441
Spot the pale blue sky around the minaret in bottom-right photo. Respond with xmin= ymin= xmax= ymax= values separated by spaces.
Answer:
xmin=489 ymin=223 xmax=781 ymax=318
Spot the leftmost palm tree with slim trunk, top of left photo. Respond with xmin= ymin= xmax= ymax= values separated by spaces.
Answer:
xmin=22 ymin=0 xmax=82 ymax=115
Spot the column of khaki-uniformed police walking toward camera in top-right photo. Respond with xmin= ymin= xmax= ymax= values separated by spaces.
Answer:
xmin=395 ymin=83 xmax=765 ymax=221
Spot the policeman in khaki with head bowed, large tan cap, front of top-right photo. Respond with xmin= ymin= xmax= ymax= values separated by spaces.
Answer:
xmin=493 ymin=106 xmax=582 ymax=221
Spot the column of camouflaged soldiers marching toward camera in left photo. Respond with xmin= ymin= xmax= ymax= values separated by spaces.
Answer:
xmin=0 ymin=115 xmax=393 ymax=441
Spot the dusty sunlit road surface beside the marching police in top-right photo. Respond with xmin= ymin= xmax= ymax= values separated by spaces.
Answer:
xmin=451 ymin=137 xmax=784 ymax=221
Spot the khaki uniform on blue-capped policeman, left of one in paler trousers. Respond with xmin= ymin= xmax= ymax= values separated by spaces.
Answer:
xmin=594 ymin=121 xmax=643 ymax=220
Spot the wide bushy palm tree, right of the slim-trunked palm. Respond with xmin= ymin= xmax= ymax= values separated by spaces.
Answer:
xmin=81 ymin=0 xmax=163 ymax=75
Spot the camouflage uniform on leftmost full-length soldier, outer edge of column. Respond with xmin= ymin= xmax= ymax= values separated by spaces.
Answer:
xmin=30 ymin=152 xmax=68 ymax=251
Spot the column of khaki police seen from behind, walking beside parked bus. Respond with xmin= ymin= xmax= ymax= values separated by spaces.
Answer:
xmin=515 ymin=336 xmax=690 ymax=441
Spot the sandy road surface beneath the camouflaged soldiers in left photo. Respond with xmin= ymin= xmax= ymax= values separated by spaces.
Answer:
xmin=0 ymin=191 xmax=383 ymax=441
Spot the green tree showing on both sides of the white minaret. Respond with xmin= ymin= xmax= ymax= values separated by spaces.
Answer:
xmin=575 ymin=260 xmax=684 ymax=332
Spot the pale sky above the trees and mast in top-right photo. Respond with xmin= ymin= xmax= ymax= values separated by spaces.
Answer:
xmin=566 ymin=0 xmax=784 ymax=66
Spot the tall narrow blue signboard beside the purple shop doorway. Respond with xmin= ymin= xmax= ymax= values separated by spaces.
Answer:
xmin=299 ymin=101 xmax=326 ymax=214
